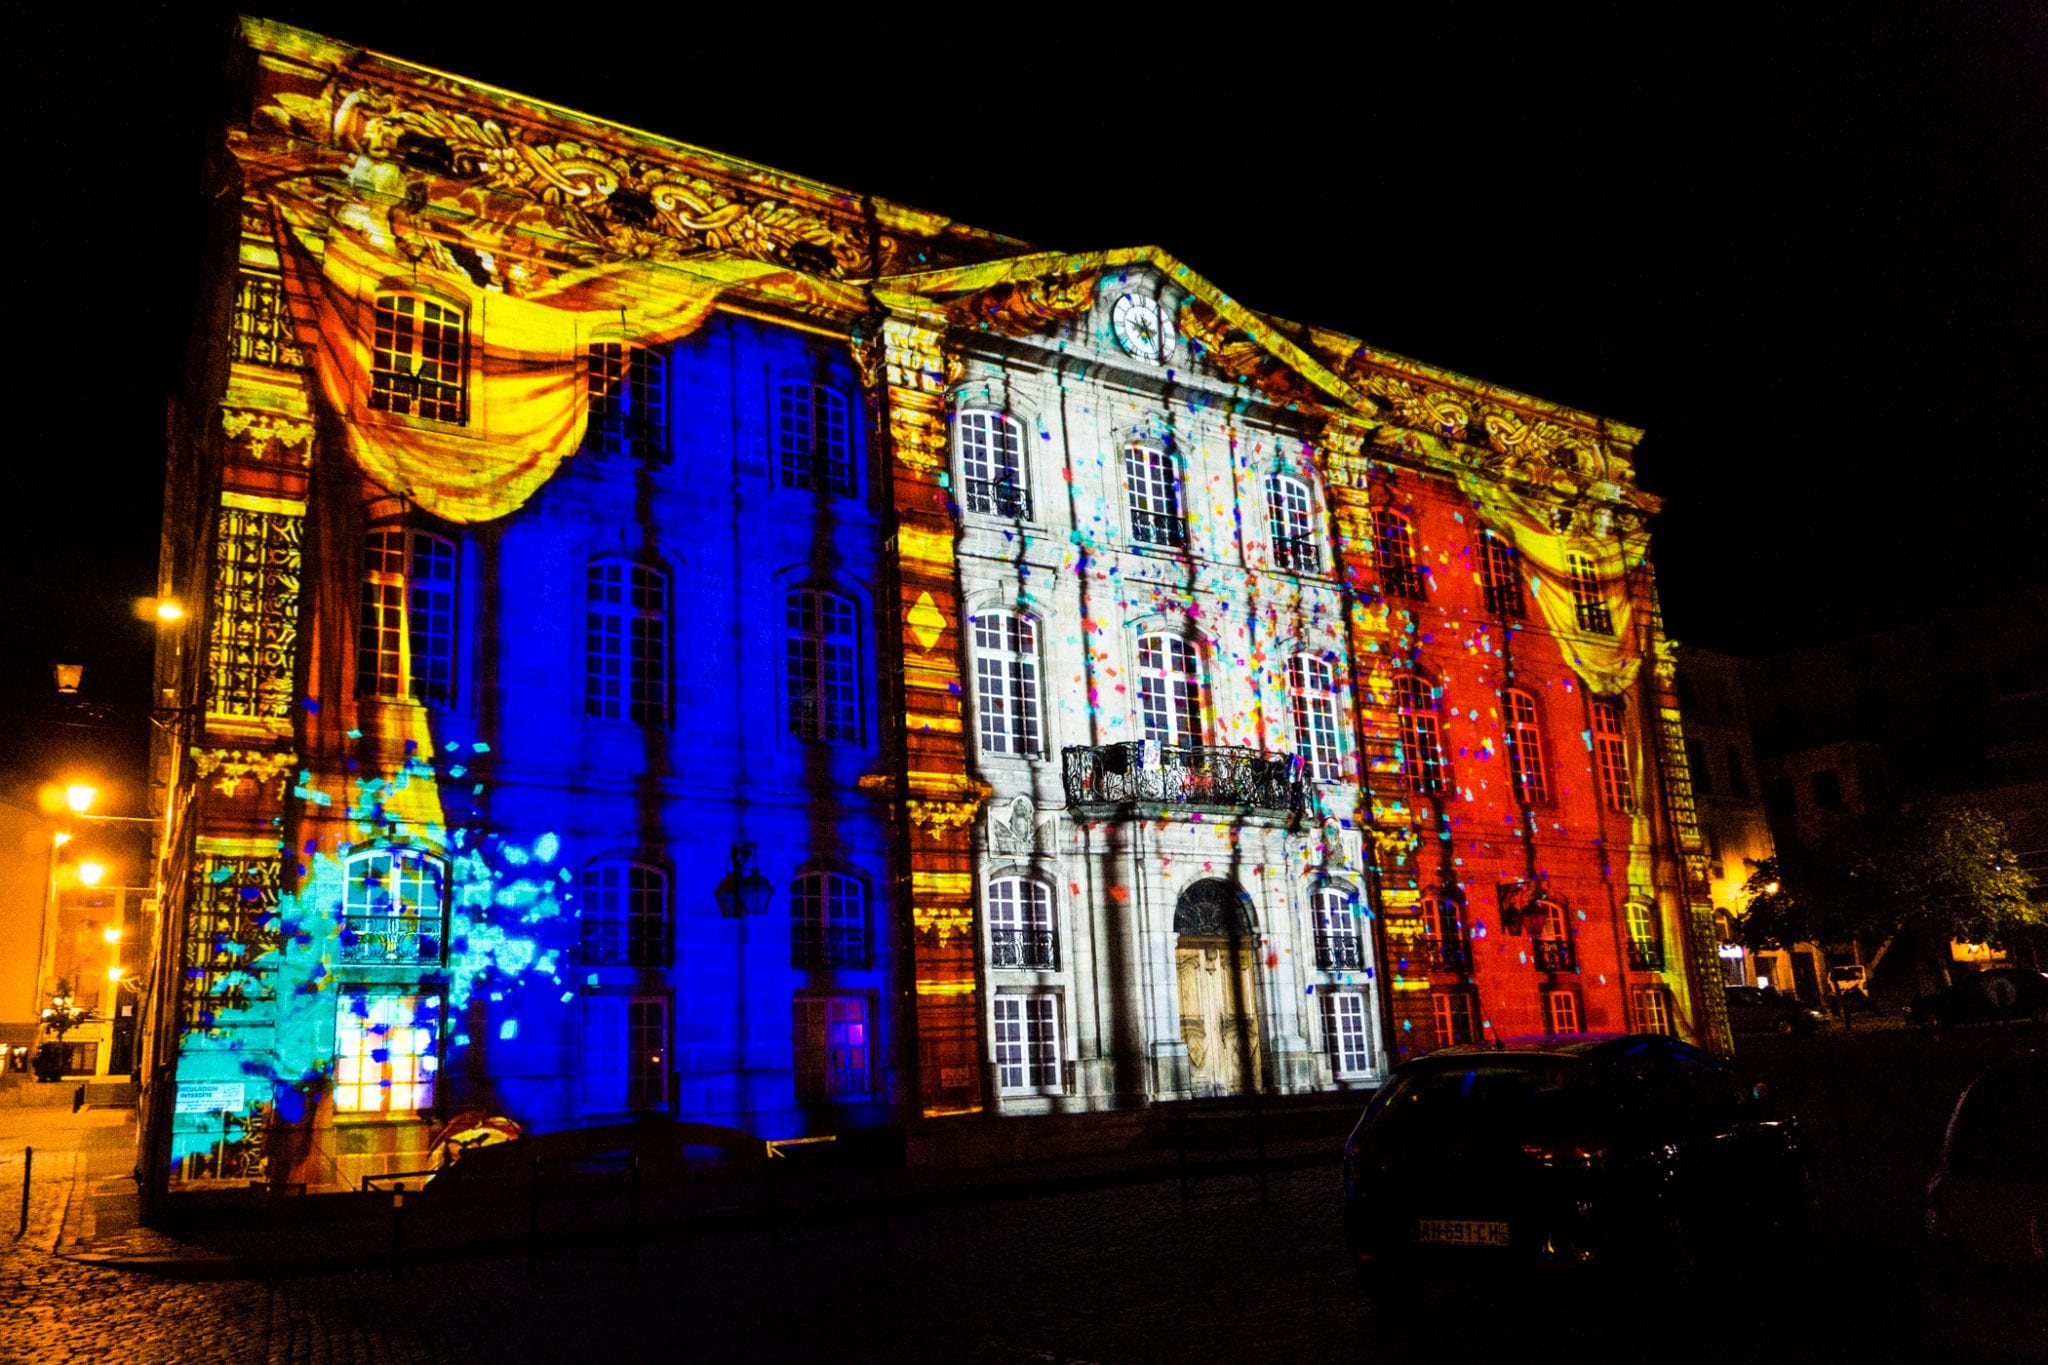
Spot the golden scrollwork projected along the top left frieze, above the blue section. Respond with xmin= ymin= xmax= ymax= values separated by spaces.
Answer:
xmin=262 ymin=82 xmax=872 ymax=278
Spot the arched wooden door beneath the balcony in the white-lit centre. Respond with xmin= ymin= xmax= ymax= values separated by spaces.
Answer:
xmin=1174 ymin=878 xmax=1262 ymax=1095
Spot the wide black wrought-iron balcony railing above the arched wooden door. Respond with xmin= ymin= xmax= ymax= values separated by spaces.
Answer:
xmin=1063 ymin=739 xmax=1300 ymax=814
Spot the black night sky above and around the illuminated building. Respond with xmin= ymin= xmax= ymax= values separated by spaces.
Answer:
xmin=0 ymin=0 xmax=2048 ymax=785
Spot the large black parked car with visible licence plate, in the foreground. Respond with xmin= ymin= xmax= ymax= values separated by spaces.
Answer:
xmin=1343 ymin=1033 xmax=1812 ymax=1289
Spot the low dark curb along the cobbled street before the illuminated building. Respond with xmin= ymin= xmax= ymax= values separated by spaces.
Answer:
xmin=51 ymin=1148 xmax=1339 ymax=1281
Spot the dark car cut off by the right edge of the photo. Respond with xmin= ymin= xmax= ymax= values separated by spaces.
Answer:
xmin=1925 ymin=1052 xmax=2048 ymax=1275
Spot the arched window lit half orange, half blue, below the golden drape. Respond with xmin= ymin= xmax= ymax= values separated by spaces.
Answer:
xmin=356 ymin=526 xmax=455 ymax=704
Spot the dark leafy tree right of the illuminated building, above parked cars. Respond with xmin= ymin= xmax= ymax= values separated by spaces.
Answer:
xmin=1737 ymin=804 xmax=2044 ymax=948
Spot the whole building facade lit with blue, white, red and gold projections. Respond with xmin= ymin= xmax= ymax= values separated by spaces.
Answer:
xmin=152 ymin=20 xmax=1724 ymax=1189
